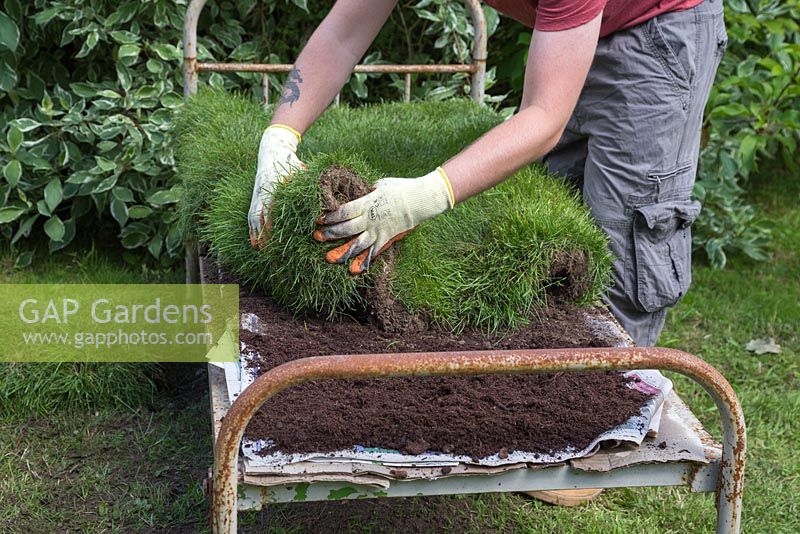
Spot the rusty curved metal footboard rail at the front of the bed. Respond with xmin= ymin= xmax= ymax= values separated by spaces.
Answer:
xmin=212 ymin=348 xmax=746 ymax=534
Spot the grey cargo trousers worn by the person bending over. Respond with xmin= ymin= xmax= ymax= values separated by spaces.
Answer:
xmin=545 ymin=0 xmax=728 ymax=346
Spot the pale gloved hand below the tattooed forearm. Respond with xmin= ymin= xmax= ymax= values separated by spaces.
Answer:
xmin=247 ymin=124 xmax=305 ymax=248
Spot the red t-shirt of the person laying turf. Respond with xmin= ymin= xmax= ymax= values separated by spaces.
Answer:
xmin=484 ymin=0 xmax=703 ymax=37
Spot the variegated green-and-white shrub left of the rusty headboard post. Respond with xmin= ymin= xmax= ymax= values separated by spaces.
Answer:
xmin=0 ymin=0 xmax=191 ymax=265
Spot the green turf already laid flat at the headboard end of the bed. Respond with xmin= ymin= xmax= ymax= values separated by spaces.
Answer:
xmin=175 ymin=89 xmax=501 ymax=243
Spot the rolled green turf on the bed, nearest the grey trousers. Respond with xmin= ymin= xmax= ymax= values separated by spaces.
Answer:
xmin=392 ymin=167 xmax=611 ymax=331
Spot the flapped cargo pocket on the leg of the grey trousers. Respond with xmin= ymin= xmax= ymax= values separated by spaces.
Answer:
xmin=629 ymin=200 xmax=700 ymax=312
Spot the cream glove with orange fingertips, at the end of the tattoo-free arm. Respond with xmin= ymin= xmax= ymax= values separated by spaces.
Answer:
xmin=314 ymin=167 xmax=455 ymax=274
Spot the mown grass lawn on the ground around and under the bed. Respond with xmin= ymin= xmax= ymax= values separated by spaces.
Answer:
xmin=0 ymin=180 xmax=800 ymax=533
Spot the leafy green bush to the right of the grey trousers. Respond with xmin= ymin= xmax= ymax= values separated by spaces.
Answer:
xmin=695 ymin=0 xmax=800 ymax=266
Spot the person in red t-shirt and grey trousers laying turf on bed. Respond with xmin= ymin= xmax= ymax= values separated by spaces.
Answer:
xmin=248 ymin=0 xmax=727 ymax=503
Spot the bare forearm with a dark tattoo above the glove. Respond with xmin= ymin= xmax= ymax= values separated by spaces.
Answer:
xmin=272 ymin=0 xmax=396 ymax=133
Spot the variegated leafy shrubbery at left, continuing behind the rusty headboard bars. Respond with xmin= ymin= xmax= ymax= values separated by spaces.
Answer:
xmin=0 ymin=0 xmax=496 ymax=266
